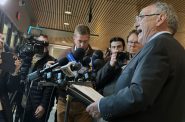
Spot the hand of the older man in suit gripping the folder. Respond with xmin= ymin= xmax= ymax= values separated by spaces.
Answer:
xmin=86 ymin=100 xmax=101 ymax=118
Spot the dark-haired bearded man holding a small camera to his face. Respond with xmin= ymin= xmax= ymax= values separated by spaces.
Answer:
xmin=96 ymin=37 xmax=128 ymax=96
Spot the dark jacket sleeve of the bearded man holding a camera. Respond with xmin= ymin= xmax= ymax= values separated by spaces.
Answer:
xmin=96 ymin=61 xmax=121 ymax=90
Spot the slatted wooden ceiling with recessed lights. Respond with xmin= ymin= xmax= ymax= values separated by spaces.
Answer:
xmin=29 ymin=0 xmax=185 ymax=49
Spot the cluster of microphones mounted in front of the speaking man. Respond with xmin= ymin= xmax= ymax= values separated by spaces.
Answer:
xmin=28 ymin=48 xmax=105 ymax=86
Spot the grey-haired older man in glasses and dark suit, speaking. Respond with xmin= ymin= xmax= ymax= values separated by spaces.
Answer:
xmin=86 ymin=2 xmax=185 ymax=122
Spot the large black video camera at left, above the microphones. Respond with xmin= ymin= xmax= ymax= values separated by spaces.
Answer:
xmin=20 ymin=37 xmax=49 ymax=57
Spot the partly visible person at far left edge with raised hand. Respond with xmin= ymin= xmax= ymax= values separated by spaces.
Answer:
xmin=0 ymin=34 xmax=21 ymax=122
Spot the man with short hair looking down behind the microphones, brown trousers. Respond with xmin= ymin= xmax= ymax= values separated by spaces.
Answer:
xmin=57 ymin=24 xmax=93 ymax=122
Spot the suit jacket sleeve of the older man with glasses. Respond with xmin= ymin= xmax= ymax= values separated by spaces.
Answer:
xmin=99 ymin=41 xmax=169 ymax=120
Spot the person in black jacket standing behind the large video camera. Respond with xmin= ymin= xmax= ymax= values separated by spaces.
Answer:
xmin=23 ymin=35 xmax=54 ymax=122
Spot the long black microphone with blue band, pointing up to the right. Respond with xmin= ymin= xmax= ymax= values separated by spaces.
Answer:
xmin=28 ymin=48 xmax=85 ymax=80
